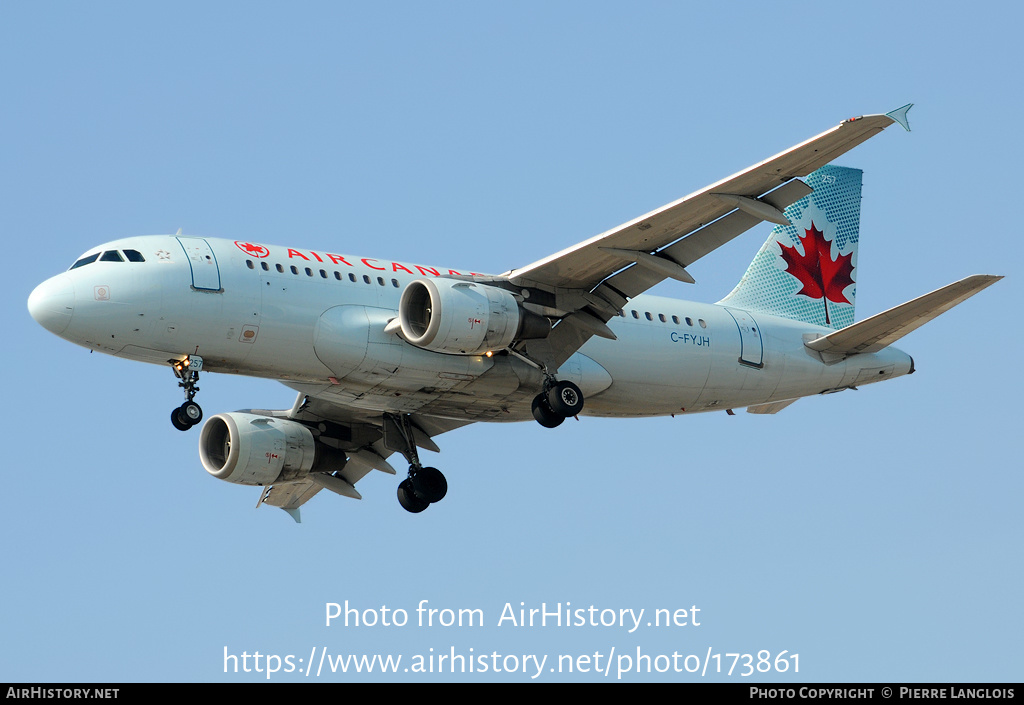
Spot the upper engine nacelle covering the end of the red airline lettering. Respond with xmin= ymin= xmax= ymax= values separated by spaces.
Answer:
xmin=398 ymin=279 xmax=551 ymax=355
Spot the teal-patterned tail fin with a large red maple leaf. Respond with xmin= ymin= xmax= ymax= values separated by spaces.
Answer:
xmin=719 ymin=164 xmax=863 ymax=330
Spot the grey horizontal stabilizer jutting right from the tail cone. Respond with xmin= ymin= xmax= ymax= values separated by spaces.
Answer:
xmin=805 ymin=275 xmax=1002 ymax=357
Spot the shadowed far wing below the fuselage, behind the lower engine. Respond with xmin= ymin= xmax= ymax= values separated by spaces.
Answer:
xmin=249 ymin=391 xmax=472 ymax=522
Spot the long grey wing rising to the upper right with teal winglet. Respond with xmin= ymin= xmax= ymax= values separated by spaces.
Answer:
xmin=495 ymin=105 xmax=910 ymax=368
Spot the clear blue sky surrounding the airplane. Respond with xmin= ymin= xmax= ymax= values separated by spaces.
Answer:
xmin=0 ymin=2 xmax=1024 ymax=681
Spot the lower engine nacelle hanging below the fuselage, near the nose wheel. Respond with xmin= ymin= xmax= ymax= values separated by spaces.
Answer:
xmin=199 ymin=412 xmax=346 ymax=485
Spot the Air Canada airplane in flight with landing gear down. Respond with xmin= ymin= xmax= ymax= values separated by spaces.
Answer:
xmin=28 ymin=105 xmax=1001 ymax=522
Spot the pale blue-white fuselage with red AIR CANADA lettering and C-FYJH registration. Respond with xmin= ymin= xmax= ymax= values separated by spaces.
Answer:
xmin=29 ymin=236 xmax=912 ymax=421
